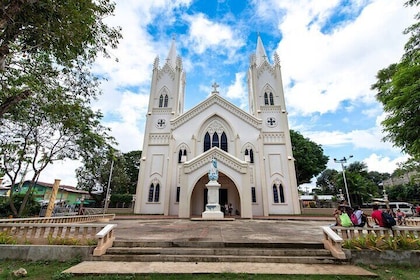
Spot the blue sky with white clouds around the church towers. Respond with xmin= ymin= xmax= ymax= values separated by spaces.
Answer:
xmin=36 ymin=0 xmax=416 ymax=188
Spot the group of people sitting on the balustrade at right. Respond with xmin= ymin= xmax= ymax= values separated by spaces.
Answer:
xmin=333 ymin=201 xmax=406 ymax=227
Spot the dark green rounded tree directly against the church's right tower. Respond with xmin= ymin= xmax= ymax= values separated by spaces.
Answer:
xmin=290 ymin=130 xmax=328 ymax=185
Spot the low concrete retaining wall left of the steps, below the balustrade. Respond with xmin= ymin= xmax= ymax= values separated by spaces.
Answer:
xmin=0 ymin=245 xmax=95 ymax=261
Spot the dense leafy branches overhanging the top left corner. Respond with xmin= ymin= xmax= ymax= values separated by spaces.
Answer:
xmin=0 ymin=0 xmax=121 ymax=116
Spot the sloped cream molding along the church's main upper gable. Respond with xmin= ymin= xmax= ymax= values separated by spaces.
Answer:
xmin=171 ymin=94 xmax=262 ymax=129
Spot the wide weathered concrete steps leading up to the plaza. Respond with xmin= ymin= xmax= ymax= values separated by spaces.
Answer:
xmin=92 ymin=240 xmax=348 ymax=264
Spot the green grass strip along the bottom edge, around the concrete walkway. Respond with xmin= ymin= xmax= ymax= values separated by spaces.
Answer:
xmin=0 ymin=260 xmax=420 ymax=280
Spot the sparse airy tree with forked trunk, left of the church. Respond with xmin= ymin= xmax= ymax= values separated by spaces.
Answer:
xmin=0 ymin=88 xmax=113 ymax=216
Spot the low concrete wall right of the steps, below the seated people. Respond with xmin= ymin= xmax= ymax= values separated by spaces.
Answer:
xmin=345 ymin=250 xmax=420 ymax=267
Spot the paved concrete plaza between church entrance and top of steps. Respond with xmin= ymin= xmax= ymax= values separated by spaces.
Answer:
xmin=110 ymin=217 xmax=333 ymax=243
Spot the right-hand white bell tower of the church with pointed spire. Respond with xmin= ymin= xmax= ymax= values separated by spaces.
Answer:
xmin=248 ymin=35 xmax=300 ymax=215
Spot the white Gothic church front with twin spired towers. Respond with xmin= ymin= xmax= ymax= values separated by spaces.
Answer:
xmin=134 ymin=36 xmax=300 ymax=218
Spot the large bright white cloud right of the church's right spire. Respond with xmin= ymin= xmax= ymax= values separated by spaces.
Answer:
xmin=271 ymin=0 xmax=413 ymax=114
